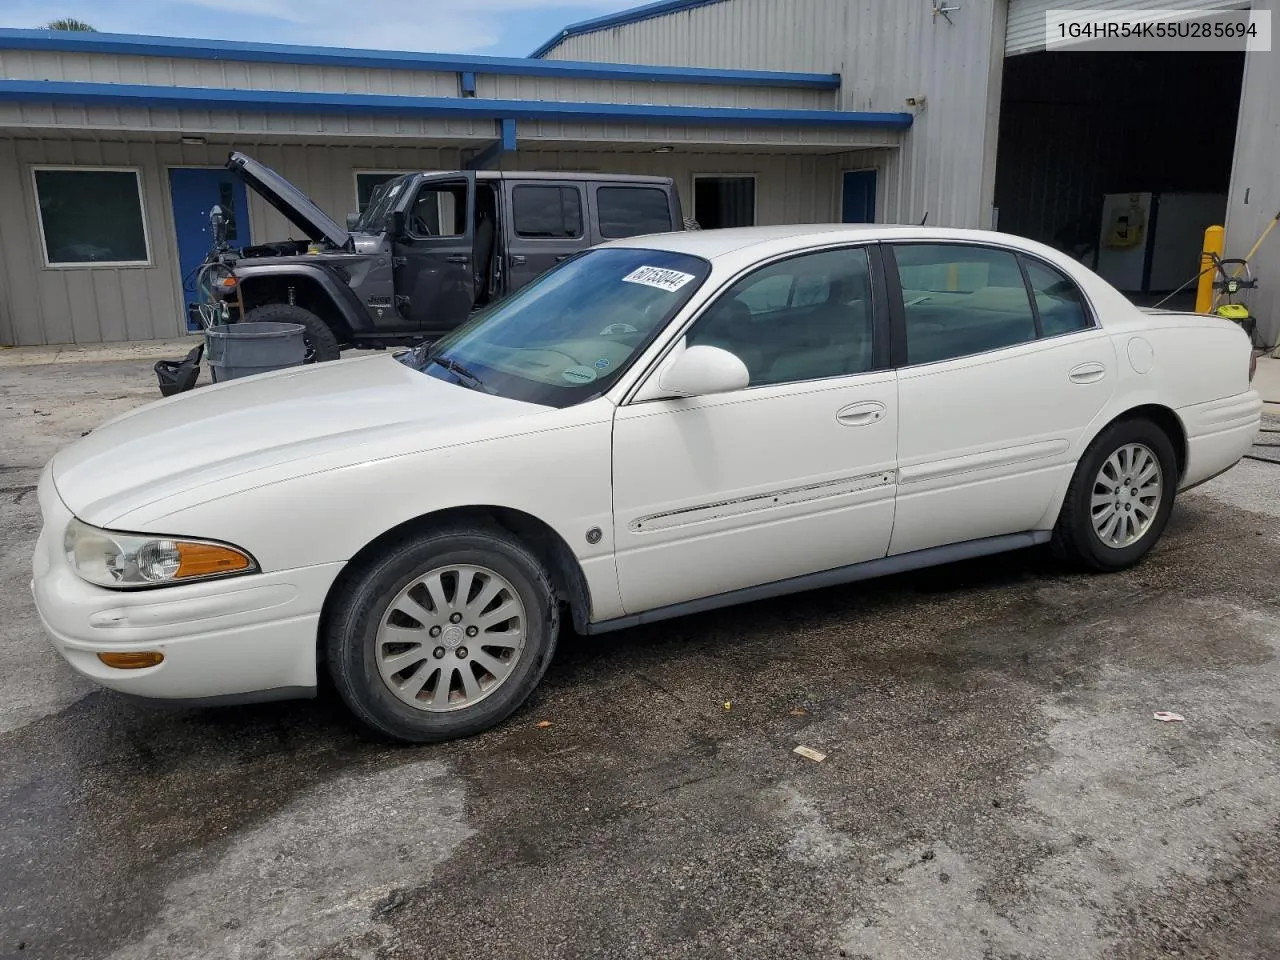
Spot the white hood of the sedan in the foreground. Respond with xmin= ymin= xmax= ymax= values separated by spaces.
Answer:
xmin=51 ymin=353 xmax=537 ymax=526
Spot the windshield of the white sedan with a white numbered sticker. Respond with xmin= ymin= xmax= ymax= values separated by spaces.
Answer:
xmin=402 ymin=247 xmax=710 ymax=407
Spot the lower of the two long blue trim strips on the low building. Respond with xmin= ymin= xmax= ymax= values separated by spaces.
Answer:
xmin=0 ymin=79 xmax=913 ymax=129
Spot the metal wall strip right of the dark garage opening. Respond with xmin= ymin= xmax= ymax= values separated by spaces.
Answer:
xmin=1226 ymin=0 xmax=1280 ymax=345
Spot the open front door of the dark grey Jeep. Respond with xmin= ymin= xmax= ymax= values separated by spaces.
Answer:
xmin=393 ymin=173 xmax=476 ymax=333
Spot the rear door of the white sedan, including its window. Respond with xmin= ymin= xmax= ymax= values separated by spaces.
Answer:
xmin=884 ymin=241 xmax=1116 ymax=554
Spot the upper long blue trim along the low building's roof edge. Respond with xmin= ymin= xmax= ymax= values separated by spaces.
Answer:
xmin=0 ymin=28 xmax=840 ymax=90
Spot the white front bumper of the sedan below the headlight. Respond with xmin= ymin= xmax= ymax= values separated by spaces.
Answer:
xmin=31 ymin=468 xmax=343 ymax=700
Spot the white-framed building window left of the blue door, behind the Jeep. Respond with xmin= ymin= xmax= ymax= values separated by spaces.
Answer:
xmin=32 ymin=166 xmax=151 ymax=266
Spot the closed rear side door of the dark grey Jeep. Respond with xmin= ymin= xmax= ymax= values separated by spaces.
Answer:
xmin=502 ymin=179 xmax=591 ymax=293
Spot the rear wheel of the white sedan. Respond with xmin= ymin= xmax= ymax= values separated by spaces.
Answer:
xmin=1051 ymin=419 xmax=1178 ymax=571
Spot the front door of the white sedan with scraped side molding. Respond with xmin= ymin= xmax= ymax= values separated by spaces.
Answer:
xmin=613 ymin=246 xmax=897 ymax=613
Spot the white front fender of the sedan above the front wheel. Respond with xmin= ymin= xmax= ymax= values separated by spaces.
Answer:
xmin=114 ymin=414 xmax=622 ymax=620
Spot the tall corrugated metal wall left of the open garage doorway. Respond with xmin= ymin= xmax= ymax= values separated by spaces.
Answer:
xmin=548 ymin=0 xmax=1006 ymax=227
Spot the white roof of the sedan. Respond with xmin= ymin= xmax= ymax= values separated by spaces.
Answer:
xmin=603 ymin=223 xmax=1056 ymax=260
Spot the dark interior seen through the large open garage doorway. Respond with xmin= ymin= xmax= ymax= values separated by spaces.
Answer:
xmin=995 ymin=50 xmax=1244 ymax=308
